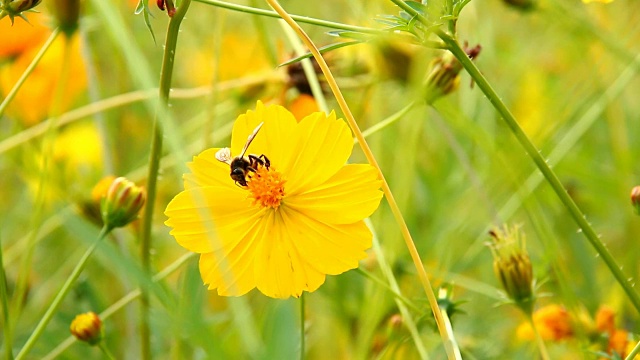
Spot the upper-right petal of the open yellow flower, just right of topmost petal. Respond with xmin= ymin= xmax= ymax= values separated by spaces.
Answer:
xmin=278 ymin=112 xmax=353 ymax=195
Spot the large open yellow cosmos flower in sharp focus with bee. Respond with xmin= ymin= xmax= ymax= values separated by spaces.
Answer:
xmin=165 ymin=102 xmax=382 ymax=298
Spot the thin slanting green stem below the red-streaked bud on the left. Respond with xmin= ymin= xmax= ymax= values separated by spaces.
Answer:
xmin=16 ymin=226 xmax=111 ymax=360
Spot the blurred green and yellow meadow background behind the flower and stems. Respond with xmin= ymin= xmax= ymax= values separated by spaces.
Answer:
xmin=0 ymin=0 xmax=640 ymax=359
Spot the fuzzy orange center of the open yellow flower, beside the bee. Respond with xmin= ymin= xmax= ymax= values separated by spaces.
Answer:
xmin=247 ymin=166 xmax=286 ymax=209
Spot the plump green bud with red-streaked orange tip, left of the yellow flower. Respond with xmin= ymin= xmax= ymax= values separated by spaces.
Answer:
xmin=101 ymin=177 xmax=146 ymax=229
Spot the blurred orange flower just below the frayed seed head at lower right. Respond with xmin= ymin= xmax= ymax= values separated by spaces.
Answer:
xmin=516 ymin=304 xmax=573 ymax=341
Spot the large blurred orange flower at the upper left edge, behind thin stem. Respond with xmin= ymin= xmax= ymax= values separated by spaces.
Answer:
xmin=0 ymin=35 xmax=87 ymax=126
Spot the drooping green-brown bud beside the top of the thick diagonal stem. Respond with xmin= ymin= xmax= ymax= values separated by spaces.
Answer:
xmin=424 ymin=45 xmax=482 ymax=104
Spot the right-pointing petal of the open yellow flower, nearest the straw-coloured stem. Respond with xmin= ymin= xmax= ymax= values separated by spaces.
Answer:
xmin=283 ymin=164 xmax=382 ymax=224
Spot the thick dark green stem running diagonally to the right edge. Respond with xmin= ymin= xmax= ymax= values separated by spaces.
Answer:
xmin=436 ymin=30 xmax=640 ymax=312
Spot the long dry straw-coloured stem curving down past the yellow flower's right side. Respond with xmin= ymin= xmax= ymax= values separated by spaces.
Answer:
xmin=267 ymin=0 xmax=453 ymax=357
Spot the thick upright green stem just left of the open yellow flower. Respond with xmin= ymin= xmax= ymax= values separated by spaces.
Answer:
xmin=140 ymin=0 xmax=191 ymax=360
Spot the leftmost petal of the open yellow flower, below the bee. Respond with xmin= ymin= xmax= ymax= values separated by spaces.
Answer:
xmin=165 ymin=186 xmax=264 ymax=253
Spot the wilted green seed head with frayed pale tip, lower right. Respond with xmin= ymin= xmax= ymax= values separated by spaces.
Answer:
xmin=489 ymin=225 xmax=535 ymax=314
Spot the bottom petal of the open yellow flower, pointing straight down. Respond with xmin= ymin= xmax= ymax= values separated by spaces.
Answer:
xmin=254 ymin=211 xmax=325 ymax=298
